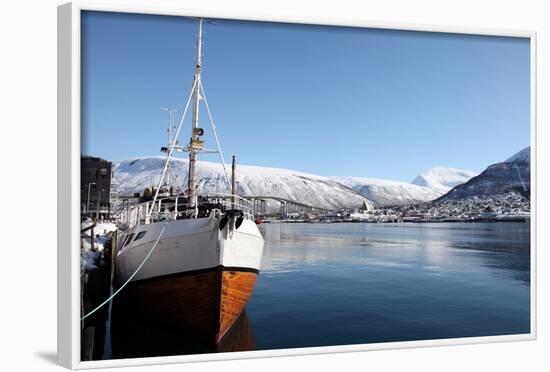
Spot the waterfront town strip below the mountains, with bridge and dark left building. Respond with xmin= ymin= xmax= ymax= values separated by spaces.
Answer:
xmin=81 ymin=157 xmax=531 ymax=227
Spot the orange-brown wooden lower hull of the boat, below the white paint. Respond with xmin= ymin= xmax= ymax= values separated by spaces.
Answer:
xmin=115 ymin=266 xmax=258 ymax=345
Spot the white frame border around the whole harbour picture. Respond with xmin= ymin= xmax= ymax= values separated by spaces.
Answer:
xmin=57 ymin=1 xmax=538 ymax=369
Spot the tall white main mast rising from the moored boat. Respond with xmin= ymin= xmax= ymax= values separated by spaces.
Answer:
xmin=191 ymin=18 xmax=206 ymax=208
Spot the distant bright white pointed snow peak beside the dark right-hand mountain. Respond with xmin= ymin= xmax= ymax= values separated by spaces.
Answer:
xmin=412 ymin=167 xmax=477 ymax=194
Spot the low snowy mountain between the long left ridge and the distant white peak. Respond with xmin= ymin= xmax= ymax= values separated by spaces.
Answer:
xmin=332 ymin=177 xmax=444 ymax=206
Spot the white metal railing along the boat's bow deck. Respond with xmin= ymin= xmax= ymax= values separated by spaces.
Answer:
xmin=118 ymin=194 xmax=254 ymax=228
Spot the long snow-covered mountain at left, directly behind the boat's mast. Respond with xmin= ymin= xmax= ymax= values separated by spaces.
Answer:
xmin=114 ymin=157 xmax=372 ymax=209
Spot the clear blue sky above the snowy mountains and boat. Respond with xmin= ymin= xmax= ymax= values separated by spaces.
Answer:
xmin=82 ymin=12 xmax=530 ymax=182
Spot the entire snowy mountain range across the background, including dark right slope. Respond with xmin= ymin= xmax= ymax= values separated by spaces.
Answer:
xmin=114 ymin=148 xmax=530 ymax=209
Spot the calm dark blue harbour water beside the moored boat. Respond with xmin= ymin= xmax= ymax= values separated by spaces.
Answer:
xmin=106 ymin=223 xmax=530 ymax=357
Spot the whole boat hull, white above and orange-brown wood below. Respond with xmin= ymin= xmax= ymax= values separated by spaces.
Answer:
xmin=116 ymin=216 xmax=264 ymax=344
